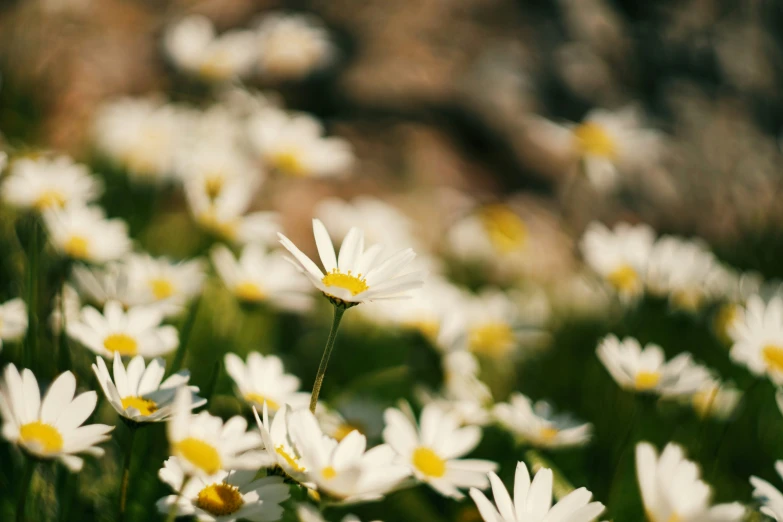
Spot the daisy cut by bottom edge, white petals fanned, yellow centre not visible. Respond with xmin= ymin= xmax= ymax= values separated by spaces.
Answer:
xmin=470 ymin=462 xmax=604 ymax=522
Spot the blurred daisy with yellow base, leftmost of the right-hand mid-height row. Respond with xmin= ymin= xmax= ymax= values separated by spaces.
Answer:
xmin=579 ymin=223 xmax=655 ymax=299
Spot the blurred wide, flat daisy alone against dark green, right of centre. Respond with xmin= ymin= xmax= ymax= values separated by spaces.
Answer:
xmin=596 ymin=335 xmax=712 ymax=397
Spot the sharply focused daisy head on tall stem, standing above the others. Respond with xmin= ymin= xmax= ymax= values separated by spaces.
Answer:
xmin=278 ymin=219 xmax=423 ymax=307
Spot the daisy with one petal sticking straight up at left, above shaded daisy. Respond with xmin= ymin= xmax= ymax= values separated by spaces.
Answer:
xmin=166 ymin=387 xmax=274 ymax=478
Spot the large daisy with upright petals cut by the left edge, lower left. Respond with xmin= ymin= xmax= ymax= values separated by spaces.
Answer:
xmin=0 ymin=364 xmax=114 ymax=471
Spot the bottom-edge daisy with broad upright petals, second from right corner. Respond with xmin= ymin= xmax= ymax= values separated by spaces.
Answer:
xmin=636 ymin=442 xmax=745 ymax=522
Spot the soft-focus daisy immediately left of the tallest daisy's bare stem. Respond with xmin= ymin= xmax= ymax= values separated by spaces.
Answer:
xmin=225 ymin=352 xmax=310 ymax=413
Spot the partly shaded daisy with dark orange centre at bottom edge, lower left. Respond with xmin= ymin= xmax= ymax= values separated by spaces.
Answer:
xmin=157 ymin=457 xmax=290 ymax=522
